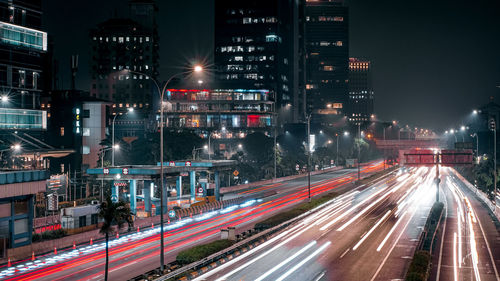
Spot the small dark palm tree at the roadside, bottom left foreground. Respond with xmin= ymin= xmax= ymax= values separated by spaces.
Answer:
xmin=99 ymin=195 xmax=134 ymax=281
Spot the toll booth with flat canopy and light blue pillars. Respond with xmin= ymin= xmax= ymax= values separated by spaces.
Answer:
xmin=87 ymin=160 xmax=236 ymax=215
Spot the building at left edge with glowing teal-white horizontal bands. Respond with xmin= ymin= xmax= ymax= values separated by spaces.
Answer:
xmin=0 ymin=0 xmax=47 ymax=144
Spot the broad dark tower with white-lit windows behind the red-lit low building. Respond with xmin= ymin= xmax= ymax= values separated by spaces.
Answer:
xmin=215 ymin=0 xmax=299 ymax=122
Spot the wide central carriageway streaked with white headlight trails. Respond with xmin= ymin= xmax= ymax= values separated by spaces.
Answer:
xmin=195 ymin=167 xmax=444 ymax=281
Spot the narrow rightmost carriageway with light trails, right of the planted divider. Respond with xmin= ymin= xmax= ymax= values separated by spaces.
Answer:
xmin=431 ymin=168 xmax=500 ymax=281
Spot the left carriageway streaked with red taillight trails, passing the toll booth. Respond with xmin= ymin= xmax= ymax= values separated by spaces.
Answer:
xmin=0 ymin=162 xmax=383 ymax=280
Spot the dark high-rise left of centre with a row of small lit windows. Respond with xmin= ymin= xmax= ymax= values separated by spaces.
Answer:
xmin=90 ymin=0 xmax=159 ymax=112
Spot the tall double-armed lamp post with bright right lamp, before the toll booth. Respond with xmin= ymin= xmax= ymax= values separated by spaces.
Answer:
xmin=128 ymin=65 xmax=202 ymax=272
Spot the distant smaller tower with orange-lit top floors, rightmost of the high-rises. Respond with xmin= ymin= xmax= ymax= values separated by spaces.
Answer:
xmin=346 ymin=58 xmax=373 ymax=124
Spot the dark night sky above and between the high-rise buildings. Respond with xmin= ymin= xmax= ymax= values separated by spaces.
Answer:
xmin=44 ymin=0 xmax=500 ymax=129
